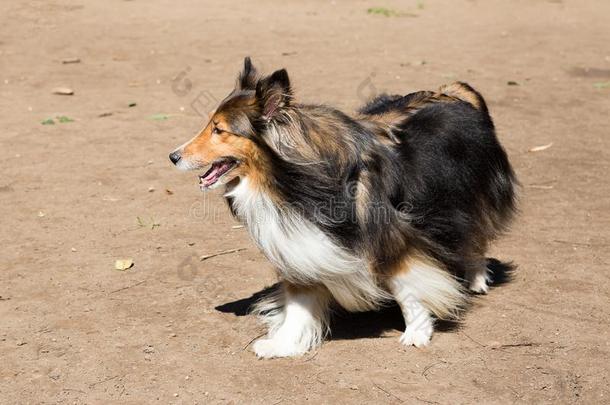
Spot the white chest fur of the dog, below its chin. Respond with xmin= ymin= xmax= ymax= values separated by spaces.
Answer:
xmin=227 ymin=179 xmax=383 ymax=311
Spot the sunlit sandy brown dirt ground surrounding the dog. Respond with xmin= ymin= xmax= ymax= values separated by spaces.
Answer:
xmin=0 ymin=0 xmax=610 ymax=404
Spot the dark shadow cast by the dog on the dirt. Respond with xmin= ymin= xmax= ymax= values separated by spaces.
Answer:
xmin=215 ymin=258 xmax=515 ymax=339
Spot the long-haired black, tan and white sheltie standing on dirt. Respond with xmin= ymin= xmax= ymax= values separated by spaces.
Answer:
xmin=170 ymin=58 xmax=516 ymax=358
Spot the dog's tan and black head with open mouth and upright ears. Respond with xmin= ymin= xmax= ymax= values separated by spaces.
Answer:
xmin=169 ymin=58 xmax=291 ymax=190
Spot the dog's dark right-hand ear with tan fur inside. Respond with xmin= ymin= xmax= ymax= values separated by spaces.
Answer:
xmin=256 ymin=69 xmax=292 ymax=121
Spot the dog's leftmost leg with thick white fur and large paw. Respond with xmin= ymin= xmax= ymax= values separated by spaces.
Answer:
xmin=253 ymin=282 xmax=330 ymax=358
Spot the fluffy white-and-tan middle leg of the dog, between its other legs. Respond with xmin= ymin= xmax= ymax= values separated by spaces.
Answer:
xmin=388 ymin=258 xmax=464 ymax=347
